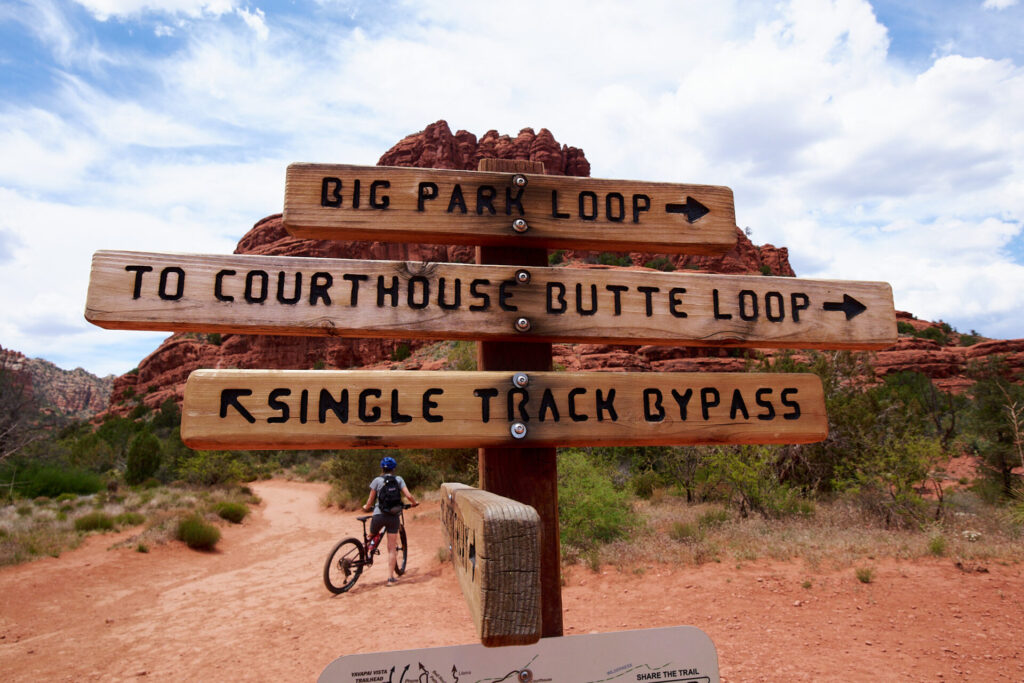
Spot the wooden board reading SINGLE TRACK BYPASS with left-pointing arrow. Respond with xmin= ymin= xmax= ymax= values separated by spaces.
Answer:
xmin=181 ymin=370 xmax=827 ymax=450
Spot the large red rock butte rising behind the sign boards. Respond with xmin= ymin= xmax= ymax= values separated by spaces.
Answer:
xmin=101 ymin=121 xmax=1024 ymax=414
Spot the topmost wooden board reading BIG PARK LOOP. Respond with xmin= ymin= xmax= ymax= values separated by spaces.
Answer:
xmin=284 ymin=164 xmax=736 ymax=254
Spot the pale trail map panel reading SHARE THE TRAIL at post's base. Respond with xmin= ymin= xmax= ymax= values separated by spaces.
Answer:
xmin=317 ymin=626 xmax=720 ymax=683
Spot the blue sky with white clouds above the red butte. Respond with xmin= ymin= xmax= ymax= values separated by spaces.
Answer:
xmin=0 ymin=0 xmax=1024 ymax=374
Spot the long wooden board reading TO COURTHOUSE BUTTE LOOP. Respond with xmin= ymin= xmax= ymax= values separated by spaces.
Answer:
xmin=85 ymin=251 xmax=897 ymax=349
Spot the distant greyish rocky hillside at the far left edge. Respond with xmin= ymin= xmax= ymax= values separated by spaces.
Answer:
xmin=0 ymin=347 xmax=114 ymax=420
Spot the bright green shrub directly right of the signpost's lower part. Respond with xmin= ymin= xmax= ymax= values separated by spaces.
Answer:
xmin=558 ymin=450 xmax=637 ymax=550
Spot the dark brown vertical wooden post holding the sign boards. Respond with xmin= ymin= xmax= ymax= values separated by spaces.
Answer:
xmin=476 ymin=159 xmax=562 ymax=638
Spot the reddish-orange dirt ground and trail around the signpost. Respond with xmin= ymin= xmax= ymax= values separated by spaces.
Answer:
xmin=0 ymin=480 xmax=1024 ymax=681
